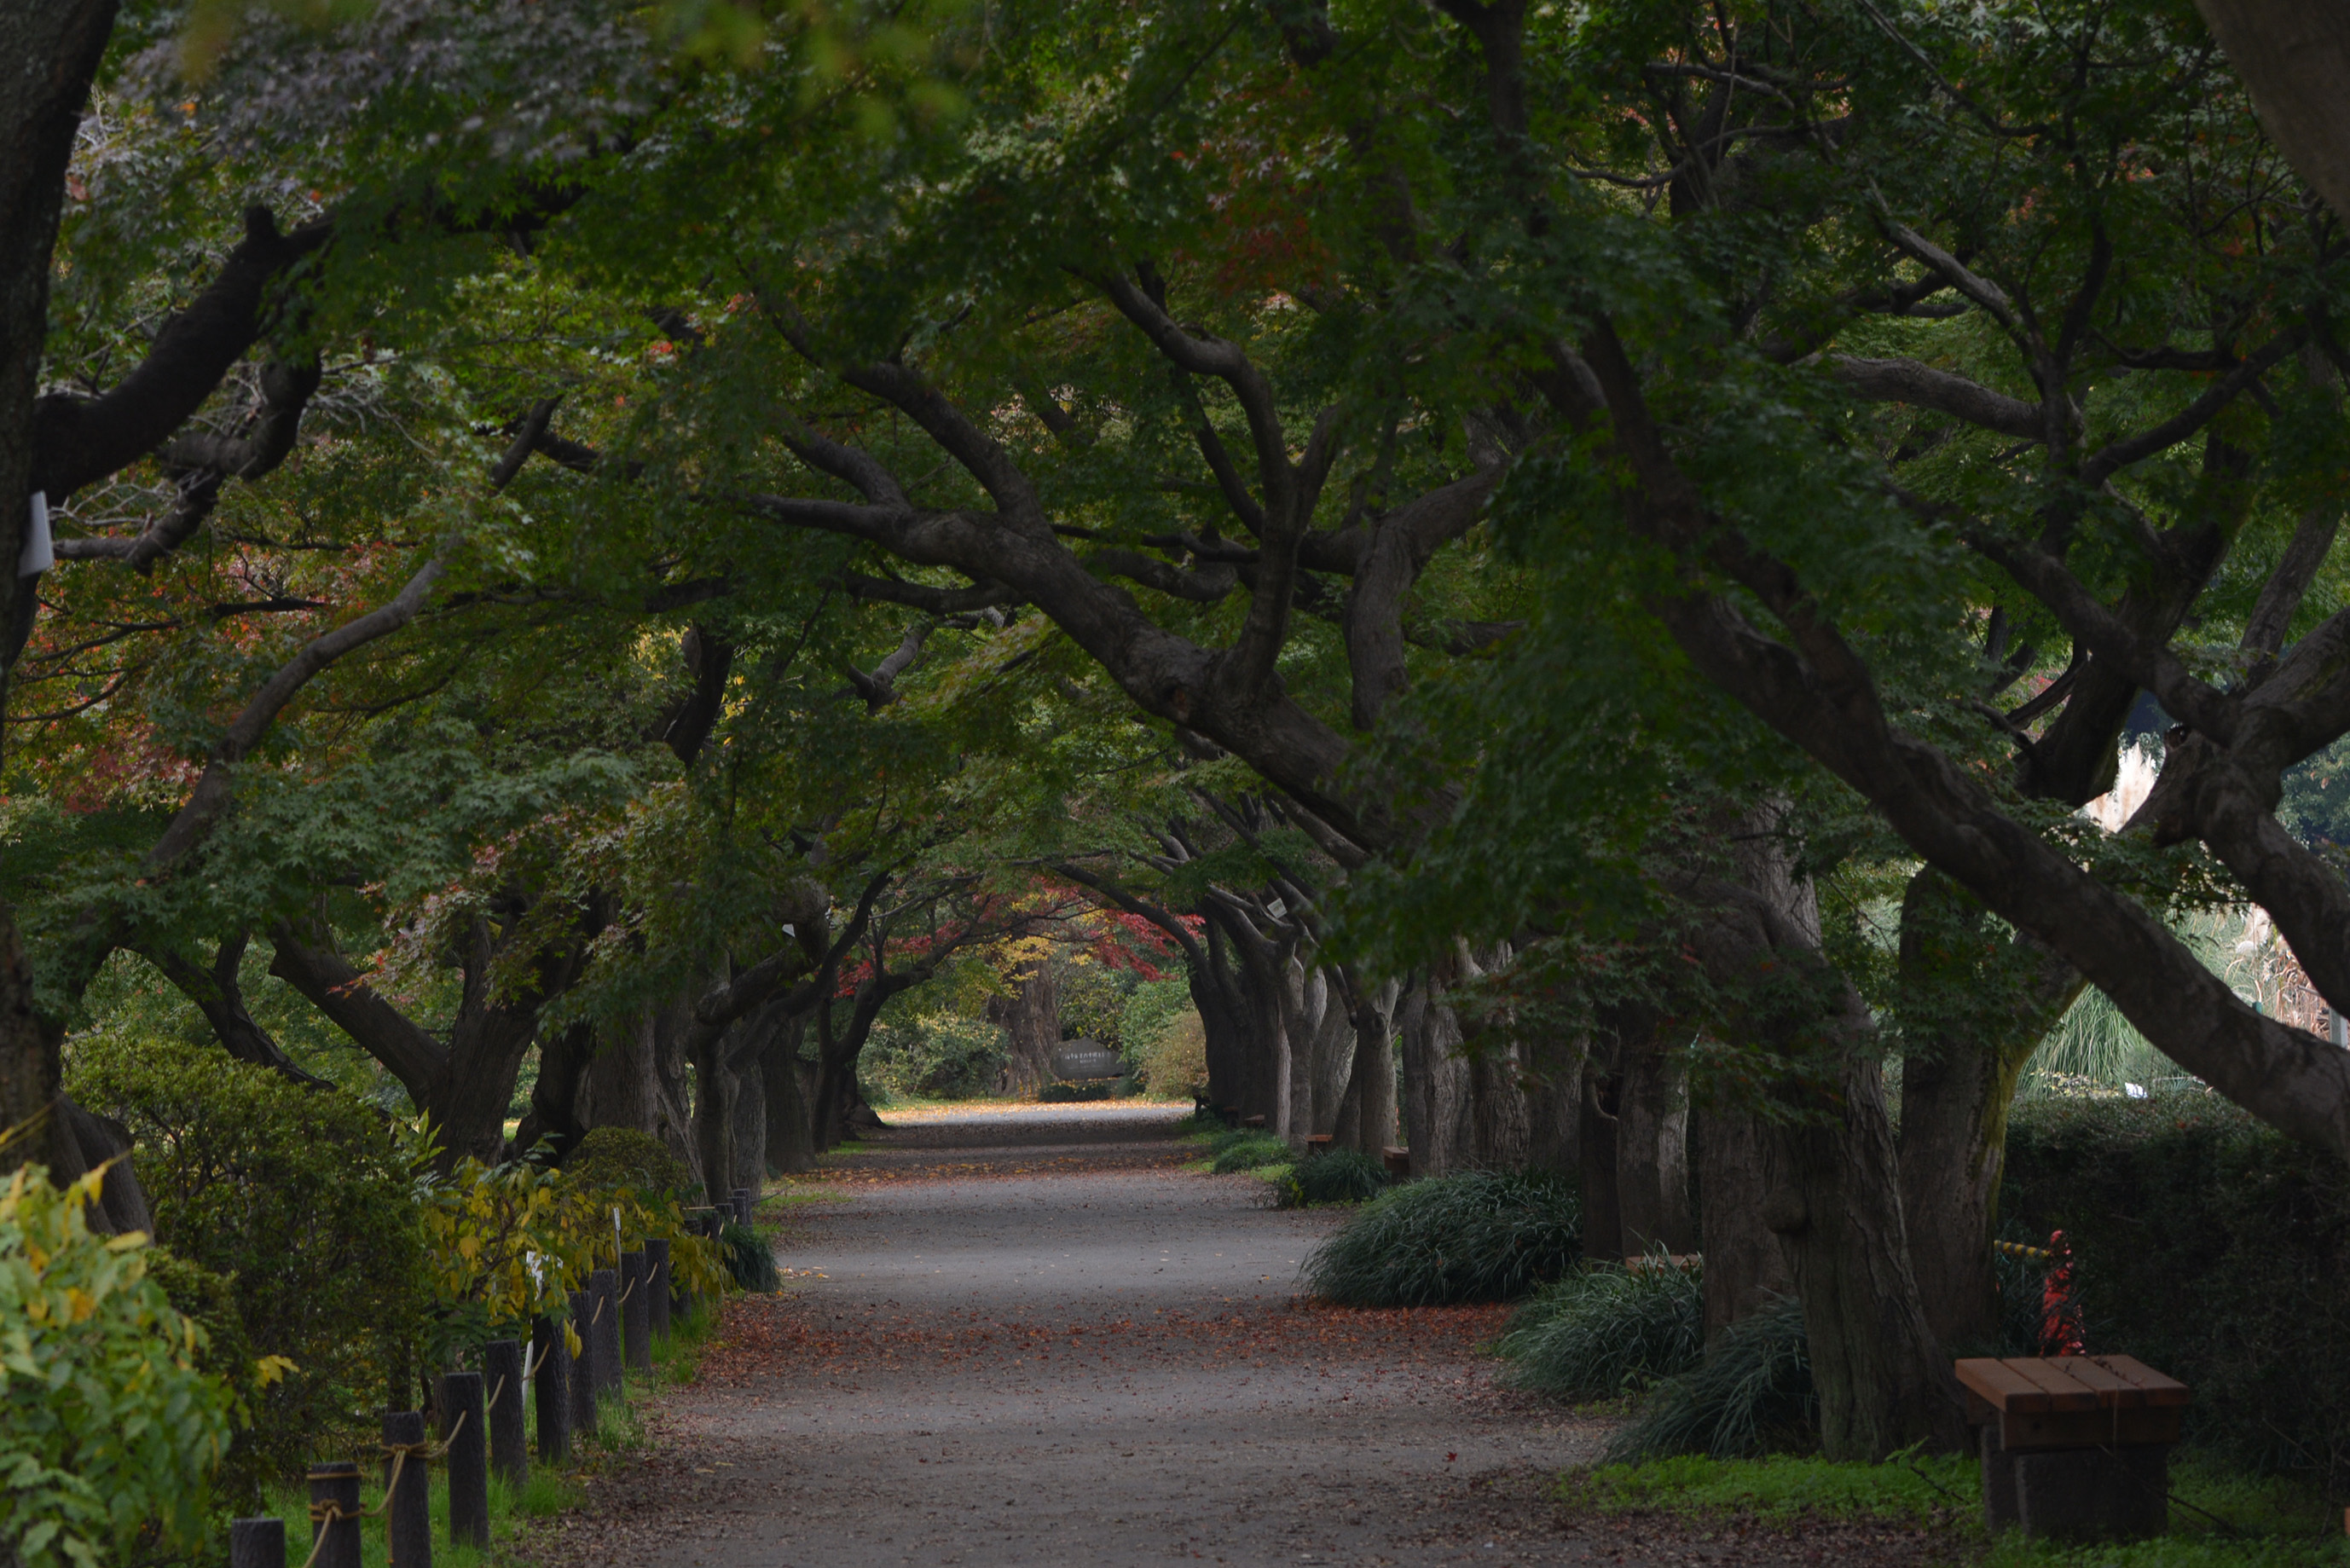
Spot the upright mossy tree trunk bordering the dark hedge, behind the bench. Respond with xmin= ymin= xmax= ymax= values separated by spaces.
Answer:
xmin=1899 ymin=870 xmax=2082 ymax=1350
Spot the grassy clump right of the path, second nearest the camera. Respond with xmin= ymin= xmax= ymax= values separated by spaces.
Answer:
xmin=1495 ymin=1258 xmax=1706 ymax=1398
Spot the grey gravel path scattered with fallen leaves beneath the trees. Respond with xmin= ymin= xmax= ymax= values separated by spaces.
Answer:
xmin=538 ymin=1105 xmax=1954 ymax=1568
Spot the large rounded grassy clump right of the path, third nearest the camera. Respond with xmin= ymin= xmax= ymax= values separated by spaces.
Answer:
xmin=1305 ymin=1171 xmax=1584 ymax=1307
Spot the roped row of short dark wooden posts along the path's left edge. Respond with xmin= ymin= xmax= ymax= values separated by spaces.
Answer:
xmin=228 ymin=1187 xmax=755 ymax=1568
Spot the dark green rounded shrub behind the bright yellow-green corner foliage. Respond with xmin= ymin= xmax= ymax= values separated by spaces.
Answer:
xmin=68 ymin=1039 xmax=430 ymax=1476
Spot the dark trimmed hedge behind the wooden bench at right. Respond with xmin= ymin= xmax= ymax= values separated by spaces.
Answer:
xmin=2000 ymin=1093 xmax=2350 ymax=1497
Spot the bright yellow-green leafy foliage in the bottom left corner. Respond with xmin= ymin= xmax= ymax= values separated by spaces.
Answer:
xmin=0 ymin=1166 xmax=233 ymax=1568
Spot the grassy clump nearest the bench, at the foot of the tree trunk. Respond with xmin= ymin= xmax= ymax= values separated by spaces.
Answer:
xmin=1605 ymin=1295 xmax=1819 ymax=1465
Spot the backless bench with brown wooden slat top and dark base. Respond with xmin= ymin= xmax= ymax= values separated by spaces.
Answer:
xmin=1958 ymin=1357 xmax=2188 ymax=1540
